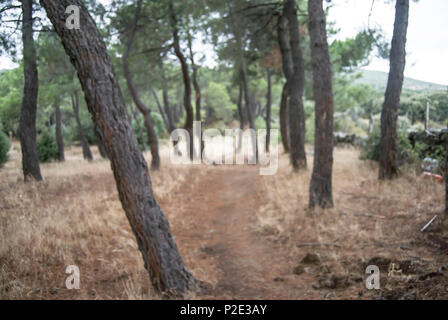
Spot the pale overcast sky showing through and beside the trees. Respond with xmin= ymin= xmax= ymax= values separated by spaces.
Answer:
xmin=0 ymin=0 xmax=448 ymax=85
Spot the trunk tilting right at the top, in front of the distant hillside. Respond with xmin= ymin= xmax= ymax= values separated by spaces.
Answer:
xmin=379 ymin=0 xmax=409 ymax=179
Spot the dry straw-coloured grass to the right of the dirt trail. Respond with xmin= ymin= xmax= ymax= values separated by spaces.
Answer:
xmin=258 ymin=148 xmax=448 ymax=298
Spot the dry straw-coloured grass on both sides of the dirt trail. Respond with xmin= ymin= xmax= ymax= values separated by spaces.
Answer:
xmin=0 ymin=143 xmax=448 ymax=299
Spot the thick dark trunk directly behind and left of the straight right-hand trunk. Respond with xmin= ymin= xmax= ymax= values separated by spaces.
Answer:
xmin=278 ymin=0 xmax=307 ymax=170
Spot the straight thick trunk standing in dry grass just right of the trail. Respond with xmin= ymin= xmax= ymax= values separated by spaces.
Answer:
xmin=308 ymin=0 xmax=333 ymax=208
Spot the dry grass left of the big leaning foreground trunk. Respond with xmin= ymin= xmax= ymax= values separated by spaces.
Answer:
xmin=0 ymin=143 xmax=184 ymax=299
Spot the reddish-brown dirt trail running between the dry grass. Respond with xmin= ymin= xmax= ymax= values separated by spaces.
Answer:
xmin=164 ymin=166 xmax=314 ymax=299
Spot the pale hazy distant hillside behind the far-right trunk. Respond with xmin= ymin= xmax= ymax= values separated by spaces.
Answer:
xmin=356 ymin=70 xmax=447 ymax=91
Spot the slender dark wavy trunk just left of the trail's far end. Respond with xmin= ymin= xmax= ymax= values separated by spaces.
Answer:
xmin=169 ymin=0 xmax=194 ymax=160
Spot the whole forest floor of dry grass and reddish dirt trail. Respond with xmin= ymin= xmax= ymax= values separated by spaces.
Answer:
xmin=0 ymin=142 xmax=448 ymax=299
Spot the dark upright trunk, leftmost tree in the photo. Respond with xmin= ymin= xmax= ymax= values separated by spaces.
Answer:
xmin=19 ymin=0 xmax=42 ymax=181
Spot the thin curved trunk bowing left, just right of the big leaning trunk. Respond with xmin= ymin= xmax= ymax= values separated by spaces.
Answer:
xmin=123 ymin=0 xmax=160 ymax=170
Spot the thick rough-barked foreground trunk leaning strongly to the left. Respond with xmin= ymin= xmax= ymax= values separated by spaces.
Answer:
xmin=40 ymin=0 xmax=197 ymax=295
